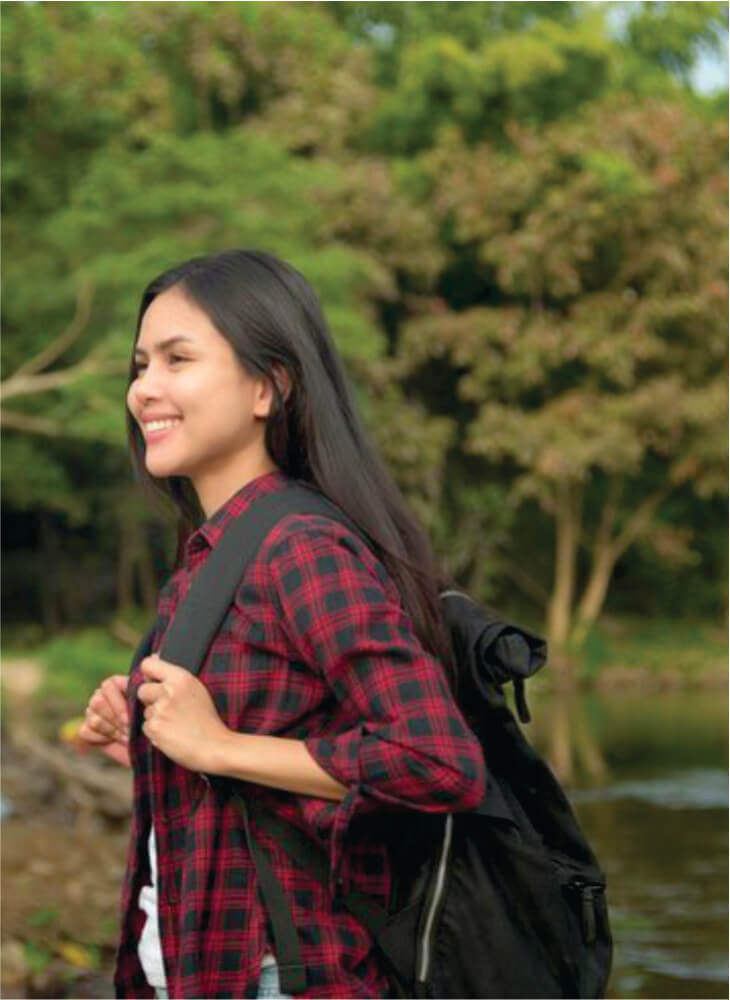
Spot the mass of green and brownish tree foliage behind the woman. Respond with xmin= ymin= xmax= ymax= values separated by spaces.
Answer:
xmin=2 ymin=2 xmax=727 ymax=640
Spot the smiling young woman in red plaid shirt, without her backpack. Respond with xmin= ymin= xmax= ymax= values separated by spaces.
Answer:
xmin=82 ymin=250 xmax=485 ymax=998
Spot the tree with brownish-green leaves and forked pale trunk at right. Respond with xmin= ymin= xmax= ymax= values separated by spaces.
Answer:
xmin=399 ymin=97 xmax=727 ymax=668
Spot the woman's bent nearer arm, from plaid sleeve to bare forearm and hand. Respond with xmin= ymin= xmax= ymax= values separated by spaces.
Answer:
xmin=138 ymin=524 xmax=485 ymax=812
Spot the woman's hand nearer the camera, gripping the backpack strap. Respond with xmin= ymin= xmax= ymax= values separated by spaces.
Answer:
xmin=137 ymin=653 xmax=231 ymax=773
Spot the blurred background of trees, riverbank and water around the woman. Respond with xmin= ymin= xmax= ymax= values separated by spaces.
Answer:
xmin=0 ymin=2 xmax=728 ymax=998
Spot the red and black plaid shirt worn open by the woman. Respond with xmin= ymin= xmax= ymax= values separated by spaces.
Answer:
xmin=115 ymin=472 xmax=485 ymax=998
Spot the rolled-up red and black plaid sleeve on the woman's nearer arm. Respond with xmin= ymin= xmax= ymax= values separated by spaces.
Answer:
xmin=267 ymin=520 xmax=485 ymax=884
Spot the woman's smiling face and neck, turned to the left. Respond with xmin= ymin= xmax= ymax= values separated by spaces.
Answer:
xmin=127 ymin=288 xmax=274 ymax=514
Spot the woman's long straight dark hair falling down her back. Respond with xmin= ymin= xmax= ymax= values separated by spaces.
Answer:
xmin=127 ymin=250 xmax=452 ymax=674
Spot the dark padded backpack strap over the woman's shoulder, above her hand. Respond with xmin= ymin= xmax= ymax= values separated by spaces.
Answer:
xmin=160 ymin=482 xmax=364 ymax=674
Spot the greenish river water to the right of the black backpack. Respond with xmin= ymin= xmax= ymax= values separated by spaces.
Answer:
xmin=528 ymin=692 xmax=728 ymax=1000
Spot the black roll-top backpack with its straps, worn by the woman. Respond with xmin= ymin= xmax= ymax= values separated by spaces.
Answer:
xmin=141 ymin=483 xmax=612 ymax=1000
